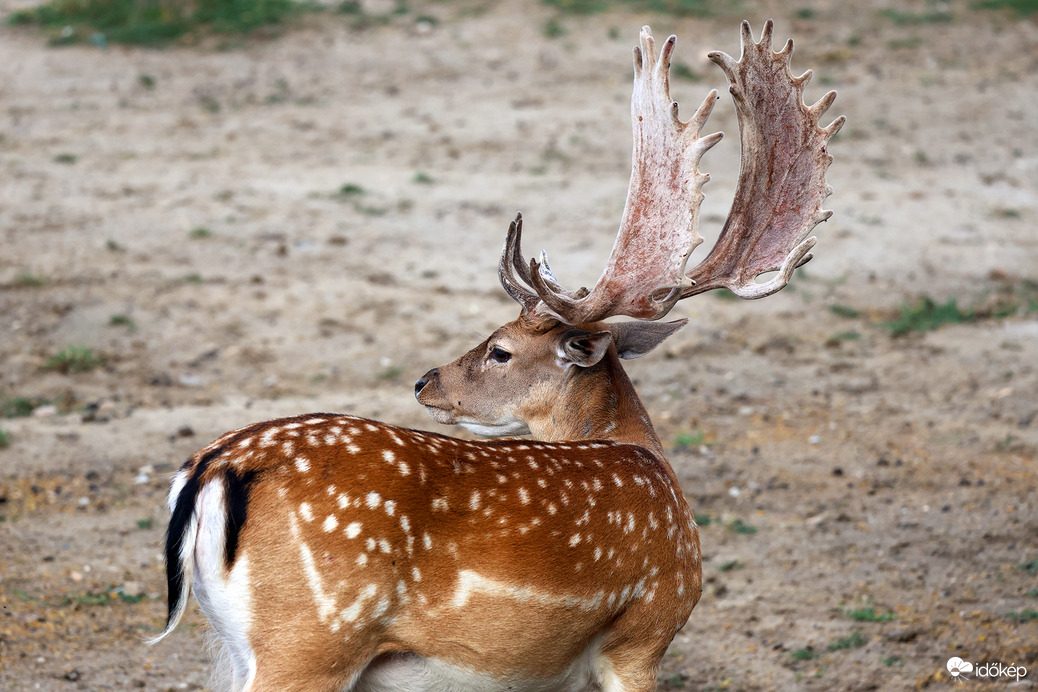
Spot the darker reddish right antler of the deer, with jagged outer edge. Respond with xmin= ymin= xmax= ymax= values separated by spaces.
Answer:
xmin=682 ymin=20 xmax=846 ymax=298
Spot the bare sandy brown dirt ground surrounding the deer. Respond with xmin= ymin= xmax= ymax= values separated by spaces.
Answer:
xmin=0 ymin=0 xmax=1038 ymax=690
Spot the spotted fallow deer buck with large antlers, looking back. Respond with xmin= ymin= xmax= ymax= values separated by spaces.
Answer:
xmin=156 ymin=21 xmax=844 ymax=692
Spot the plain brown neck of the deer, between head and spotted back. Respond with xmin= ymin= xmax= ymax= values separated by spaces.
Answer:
xmin=526 ymin=353 xmax=665 ymax=459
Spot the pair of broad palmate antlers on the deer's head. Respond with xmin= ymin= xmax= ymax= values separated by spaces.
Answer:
xmin=498 ymin=20 xmax=845 ymax=325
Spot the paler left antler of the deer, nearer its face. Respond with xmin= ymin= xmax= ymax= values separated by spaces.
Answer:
xmin=502 ymin=27 xmax=721 ymax=324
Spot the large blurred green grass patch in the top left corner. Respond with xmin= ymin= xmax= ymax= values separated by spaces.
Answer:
xmin=7 ymin=0 xmax=308 ymax=47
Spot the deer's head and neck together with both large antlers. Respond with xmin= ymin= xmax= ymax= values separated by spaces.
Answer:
xmin=415 ymin=21 xmax=844 ymax=448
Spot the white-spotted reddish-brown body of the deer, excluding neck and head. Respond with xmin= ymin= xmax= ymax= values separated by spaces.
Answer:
xmin=164 ymin=414 xmax=701 ymax=690
